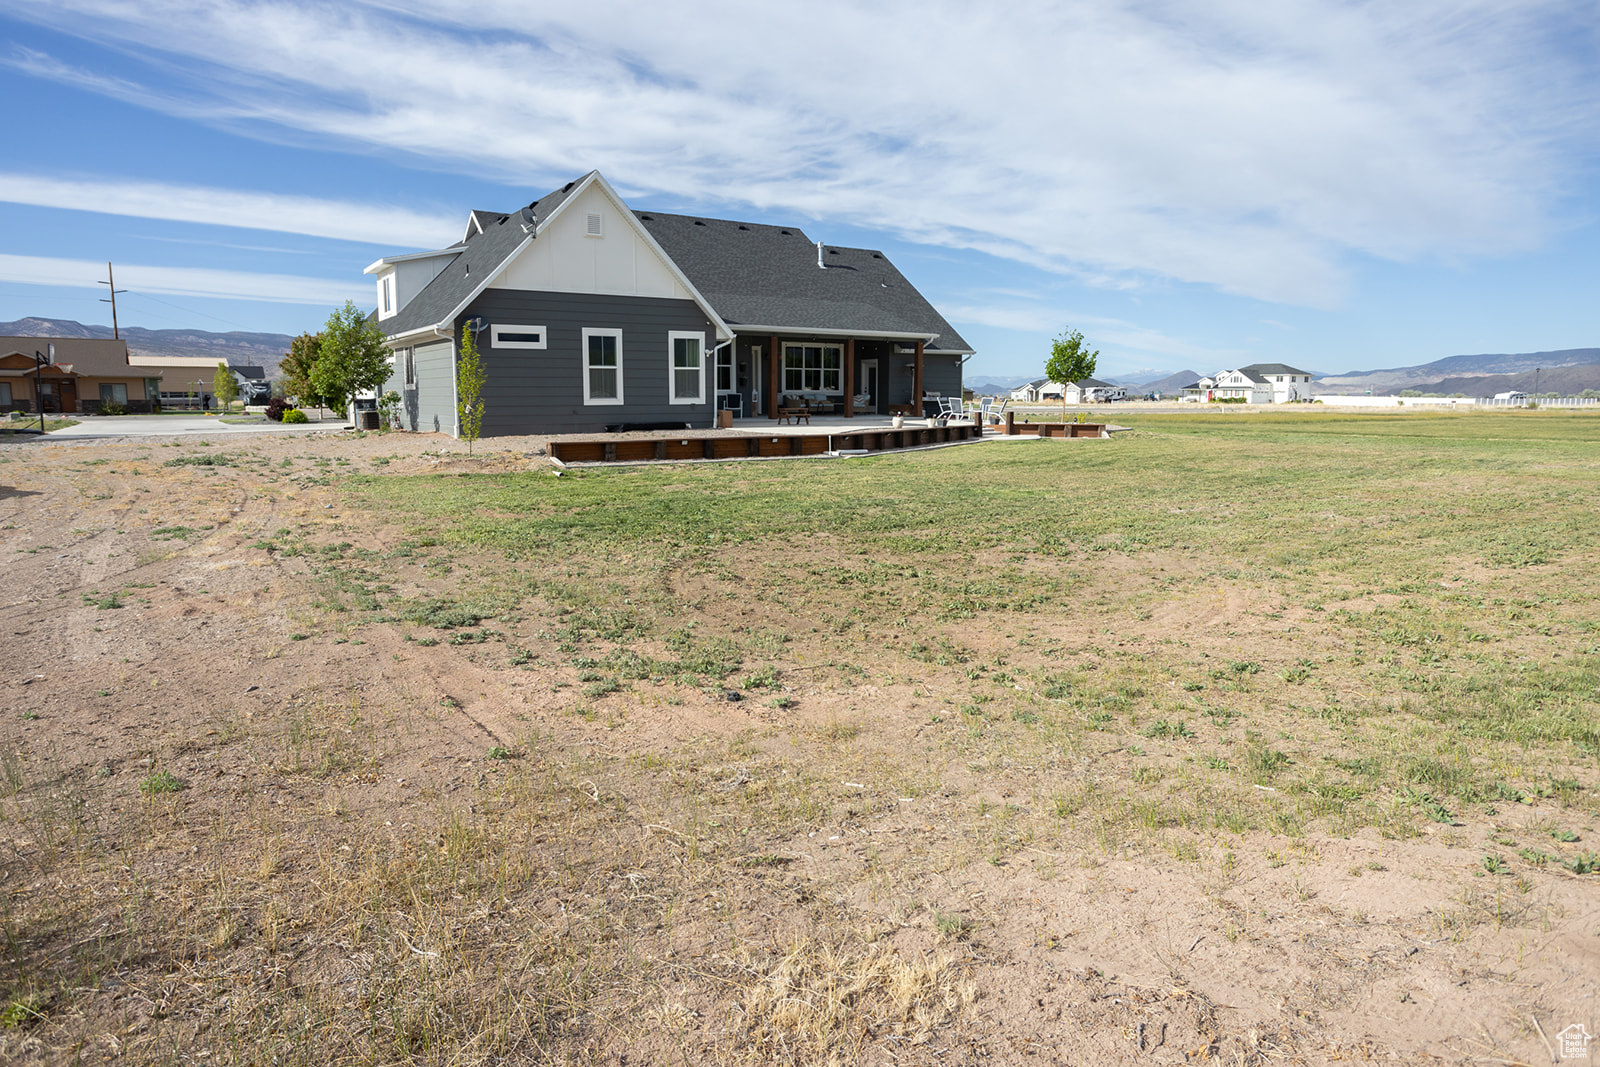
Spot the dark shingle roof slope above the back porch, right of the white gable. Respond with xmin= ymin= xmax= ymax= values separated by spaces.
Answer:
xmin=634 ymin=211 xmax=971 ymax=352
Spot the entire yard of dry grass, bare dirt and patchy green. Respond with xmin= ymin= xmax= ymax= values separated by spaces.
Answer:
xmin=0 ymin=404 xmax=1600 ymax=1065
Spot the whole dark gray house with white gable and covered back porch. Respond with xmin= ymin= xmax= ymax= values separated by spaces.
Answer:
xmin=366 ymin=171 xmax=973 ymax=437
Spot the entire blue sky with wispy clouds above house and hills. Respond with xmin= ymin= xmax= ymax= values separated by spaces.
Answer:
xmin=0 ymin=0 xmax=1600 ymax=378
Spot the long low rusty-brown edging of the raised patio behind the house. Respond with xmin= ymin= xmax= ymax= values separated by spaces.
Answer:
xmin=547 ymin=422 xmax=982 ymax=464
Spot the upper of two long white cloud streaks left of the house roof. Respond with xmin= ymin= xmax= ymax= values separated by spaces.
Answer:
xmin=0 ymin=173 xmax=461 ymax=248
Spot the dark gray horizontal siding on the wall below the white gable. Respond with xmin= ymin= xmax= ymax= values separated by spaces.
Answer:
xmin=460 ymin=290 xmax=715 ymax=437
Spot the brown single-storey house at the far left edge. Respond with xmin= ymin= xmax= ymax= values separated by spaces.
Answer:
xmin=0 ymin=338 xmax=162 ymax=414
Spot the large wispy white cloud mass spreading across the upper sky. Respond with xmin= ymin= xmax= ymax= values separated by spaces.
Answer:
xmin=10 ymin=0 xmax=1600 ymax=306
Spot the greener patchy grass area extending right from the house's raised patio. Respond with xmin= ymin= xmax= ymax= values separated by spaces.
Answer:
xmin=340 ymin=411 xmax=1600 ymax=833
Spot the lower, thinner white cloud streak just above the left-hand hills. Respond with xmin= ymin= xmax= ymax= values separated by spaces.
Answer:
xmin=0 ymin=253 xmax=373 ymax=307
